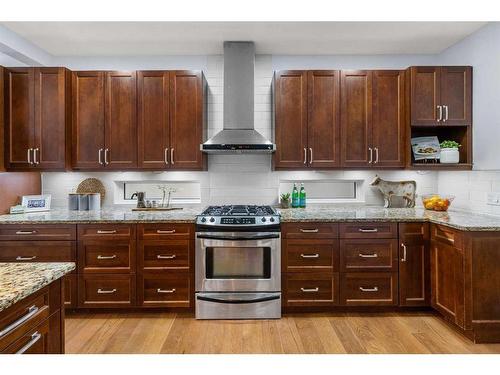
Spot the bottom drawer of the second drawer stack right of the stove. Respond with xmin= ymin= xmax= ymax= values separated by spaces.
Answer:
xmin=340 ymin=273 xmax=398 ymax=306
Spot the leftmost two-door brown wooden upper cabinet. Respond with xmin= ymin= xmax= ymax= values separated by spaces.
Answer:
xmin=4 ymin=68 xmax=71 ymax=171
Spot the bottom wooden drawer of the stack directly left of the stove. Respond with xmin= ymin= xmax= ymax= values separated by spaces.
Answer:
xmin=138 ymin=272 xmax=192 ymax=307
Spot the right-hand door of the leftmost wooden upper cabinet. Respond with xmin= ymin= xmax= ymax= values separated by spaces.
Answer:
xmin=34 ymin=68 xmax=68 ymax=169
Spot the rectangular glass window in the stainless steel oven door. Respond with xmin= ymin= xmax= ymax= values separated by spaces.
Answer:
xmin=206 ymin=247 xmax=271 ymax=279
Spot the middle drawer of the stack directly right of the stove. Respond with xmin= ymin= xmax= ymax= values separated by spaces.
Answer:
xmin=283 ymin=240 xmax=339 ymax=272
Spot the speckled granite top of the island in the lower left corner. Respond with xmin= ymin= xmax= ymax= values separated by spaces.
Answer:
xmin=0 ymin=263 xmax=75 ymax=311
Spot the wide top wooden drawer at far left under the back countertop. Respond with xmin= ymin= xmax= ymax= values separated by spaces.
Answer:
xmin=0 ymin=224 xmax=76 ymax=241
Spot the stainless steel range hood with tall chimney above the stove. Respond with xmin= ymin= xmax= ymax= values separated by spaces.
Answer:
xmin=200 ymin=42 xmax=276 ymax=153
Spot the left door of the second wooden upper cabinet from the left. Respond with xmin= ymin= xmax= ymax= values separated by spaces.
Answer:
xmin=71 ymin=71 xmax=104 ymax=169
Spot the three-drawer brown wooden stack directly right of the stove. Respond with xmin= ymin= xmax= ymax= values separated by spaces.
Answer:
xmin=281 ymin=223 xmax=339 ymax=307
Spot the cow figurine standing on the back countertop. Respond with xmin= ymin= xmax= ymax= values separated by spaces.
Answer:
xmin=370 ymin=175 xmax=417 ymax=208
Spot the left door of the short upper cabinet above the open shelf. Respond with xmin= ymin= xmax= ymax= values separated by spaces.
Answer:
xmin=410 ymin=66 xmax=441 ymax=125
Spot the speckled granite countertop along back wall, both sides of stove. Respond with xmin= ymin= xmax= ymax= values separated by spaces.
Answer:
xmin=0 ymin=204 xmax=500 ymax=231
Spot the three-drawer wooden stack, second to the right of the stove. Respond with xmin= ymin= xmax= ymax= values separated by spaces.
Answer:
xmin=339 ymin=222 xmax=398 ymax=306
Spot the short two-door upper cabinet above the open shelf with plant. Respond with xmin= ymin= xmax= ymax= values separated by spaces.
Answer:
xmin=410 ymin=66 xmax=472 ymax=126
